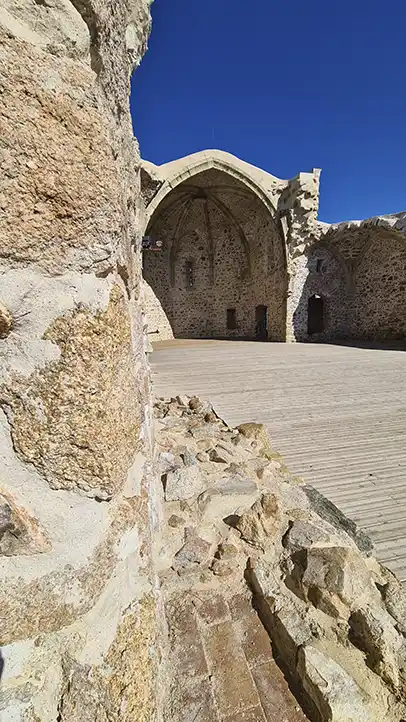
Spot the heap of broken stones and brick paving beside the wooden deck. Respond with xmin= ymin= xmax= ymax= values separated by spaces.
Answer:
xmin=155 ymin=397 xmax=406 ymax=722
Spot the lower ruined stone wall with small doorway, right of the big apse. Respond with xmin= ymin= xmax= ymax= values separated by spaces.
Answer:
xmin=293 ymin=214 xmax=406 ymax=341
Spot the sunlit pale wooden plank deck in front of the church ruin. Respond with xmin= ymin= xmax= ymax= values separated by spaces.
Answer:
xmin=151 ymin=341 xmax=406 ymax=581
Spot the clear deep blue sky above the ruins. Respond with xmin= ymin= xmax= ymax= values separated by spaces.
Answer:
xmin=131 ymin=0 xmax=406 ymax=222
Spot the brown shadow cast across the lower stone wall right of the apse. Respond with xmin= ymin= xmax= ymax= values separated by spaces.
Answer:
xmin=293 ymin=233 xmax=406 ymax=350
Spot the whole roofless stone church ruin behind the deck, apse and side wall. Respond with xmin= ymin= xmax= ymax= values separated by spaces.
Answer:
xmin=141 ymin=150 xmax=406 ymax=341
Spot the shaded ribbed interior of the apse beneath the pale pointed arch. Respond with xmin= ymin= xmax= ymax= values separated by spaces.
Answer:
xmin=144 ymin=164 xmax=287 ymax=341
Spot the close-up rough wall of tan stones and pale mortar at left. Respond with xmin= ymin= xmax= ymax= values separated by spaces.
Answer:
xmin=0 ymin=0 xmax=159 ymax=722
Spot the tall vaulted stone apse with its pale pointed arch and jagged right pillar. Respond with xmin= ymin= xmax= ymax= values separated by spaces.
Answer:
xmin=142 ymin=150 xmax=320 ymax=341
